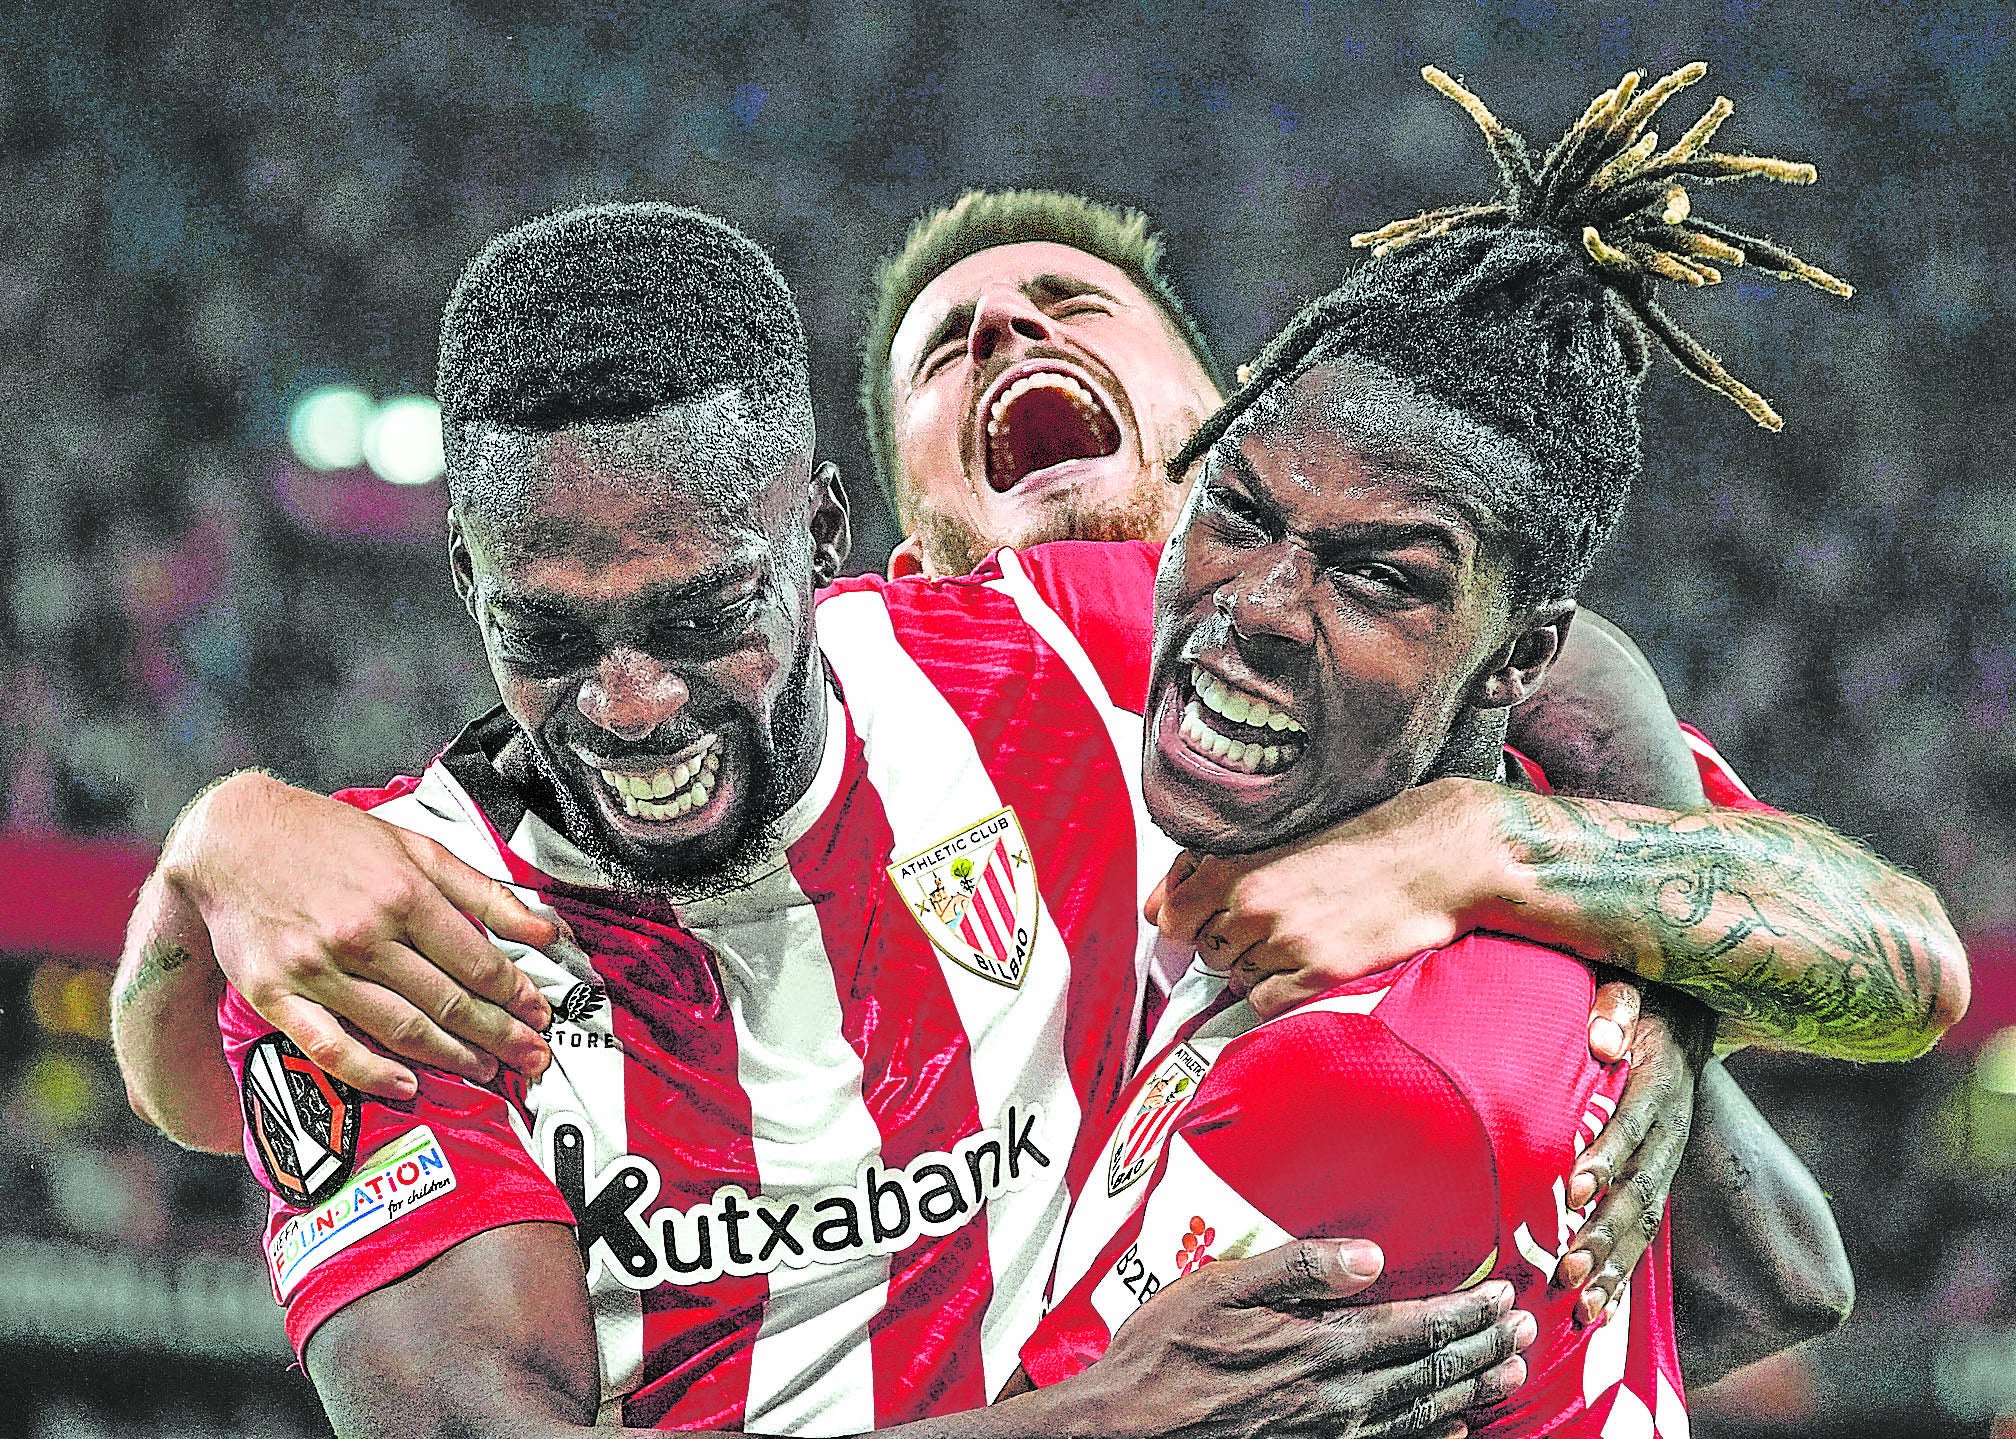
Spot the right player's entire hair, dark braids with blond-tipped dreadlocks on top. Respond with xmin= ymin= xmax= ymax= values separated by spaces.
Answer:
xmin=1171 ymin=64 xmax=1853 ymax=603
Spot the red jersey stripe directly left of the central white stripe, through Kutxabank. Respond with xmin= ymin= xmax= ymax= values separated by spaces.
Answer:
xmin=546 ymin=885 xmax=770 ymax=1429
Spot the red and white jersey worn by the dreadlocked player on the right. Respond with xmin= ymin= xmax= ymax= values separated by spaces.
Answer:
xmin=1022 ymin=933 xmax=1687 ymax=1439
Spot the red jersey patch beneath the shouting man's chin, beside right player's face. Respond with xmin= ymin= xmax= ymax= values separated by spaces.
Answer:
xmin=1008 ymin=540 xmax=1161 ymax=713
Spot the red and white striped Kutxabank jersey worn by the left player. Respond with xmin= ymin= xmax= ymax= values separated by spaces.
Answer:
xmin=222 ymin=544 xmax=1187 ymax=1435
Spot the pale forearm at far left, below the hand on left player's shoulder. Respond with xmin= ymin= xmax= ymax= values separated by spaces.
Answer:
xmin=111 ymin=869 xmax=240 ymax=1155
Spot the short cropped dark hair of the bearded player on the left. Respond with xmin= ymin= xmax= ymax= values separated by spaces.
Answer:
xmin=435 ymin=204 xmax=810 ymax=486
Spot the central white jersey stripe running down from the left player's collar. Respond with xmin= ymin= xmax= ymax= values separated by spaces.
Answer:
xmin=679 ymin=858 xmax=889 ymax=1435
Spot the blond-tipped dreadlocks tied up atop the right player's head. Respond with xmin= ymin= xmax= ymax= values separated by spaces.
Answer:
xmin=1351 ymin=60 xmax=1855 ymax=429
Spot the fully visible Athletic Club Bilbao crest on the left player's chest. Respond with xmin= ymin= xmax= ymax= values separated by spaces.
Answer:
xmin=889 ymin=810 xmax=1040 ymax=990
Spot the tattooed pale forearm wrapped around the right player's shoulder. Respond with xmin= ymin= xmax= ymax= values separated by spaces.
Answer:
xmin=1474 ymin=790 xmax=1968 ymax=1060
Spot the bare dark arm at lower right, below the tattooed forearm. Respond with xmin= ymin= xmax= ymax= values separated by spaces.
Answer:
xmin=1673 ymin=1062 xmax=1855 ymax=1387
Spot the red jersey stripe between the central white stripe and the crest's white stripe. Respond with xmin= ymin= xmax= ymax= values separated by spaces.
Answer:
xmin=790 ymin=728 xmax=994 ymax=1429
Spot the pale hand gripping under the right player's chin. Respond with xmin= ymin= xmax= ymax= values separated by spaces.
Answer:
xmin=1147 ymin=780 xmax=1500 ymax=1018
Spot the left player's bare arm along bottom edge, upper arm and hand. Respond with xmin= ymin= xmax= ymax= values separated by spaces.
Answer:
xmin=306 ymin=1223 xmax=1516 ymax=1439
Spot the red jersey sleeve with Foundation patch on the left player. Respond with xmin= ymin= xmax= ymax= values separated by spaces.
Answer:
xmin=218 ymin=990 xmax=575 ymax=1356
